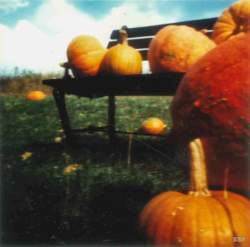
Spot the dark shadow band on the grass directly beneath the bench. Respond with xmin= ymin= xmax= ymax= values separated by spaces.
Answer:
xmin=25 ymin=134 xmax=187 ymax=169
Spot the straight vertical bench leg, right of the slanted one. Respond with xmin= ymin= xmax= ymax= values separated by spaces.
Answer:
xmin=108 ymin=95 xmax=116 ymax=143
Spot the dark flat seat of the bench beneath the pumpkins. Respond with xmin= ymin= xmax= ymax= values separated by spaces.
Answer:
xmin=43 ymin=72 xmax=184 ymax=98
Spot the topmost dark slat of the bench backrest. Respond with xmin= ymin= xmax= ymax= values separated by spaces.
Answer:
xmin=110 ymin=17 xmax=217 ymax=39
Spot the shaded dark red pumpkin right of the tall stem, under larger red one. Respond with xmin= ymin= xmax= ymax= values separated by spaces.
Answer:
xmin=202 ymin=137 xmax=250 ymax=192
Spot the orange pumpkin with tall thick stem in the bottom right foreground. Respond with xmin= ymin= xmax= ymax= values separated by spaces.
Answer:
xmin=139 ymin=139 xmax=250 ymax=247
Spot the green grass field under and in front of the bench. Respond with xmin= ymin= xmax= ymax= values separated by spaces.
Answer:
xmin=0 ymin=96 xmax=188 ymax=245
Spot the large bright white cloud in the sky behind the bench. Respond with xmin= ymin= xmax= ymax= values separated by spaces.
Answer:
xmin=0 ymin=0 xmax=182 ymax=72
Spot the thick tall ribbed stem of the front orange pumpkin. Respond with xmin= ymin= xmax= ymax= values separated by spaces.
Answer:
xmin=189 ymin=139 xmax=210 ymax=196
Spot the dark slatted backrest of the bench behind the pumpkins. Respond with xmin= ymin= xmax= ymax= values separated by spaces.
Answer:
xmin=108 ymin=18 xmax=217 ymax=60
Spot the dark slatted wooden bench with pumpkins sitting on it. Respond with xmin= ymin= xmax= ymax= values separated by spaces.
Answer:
xmin=43 ymin=18 xmax=216 ymax=140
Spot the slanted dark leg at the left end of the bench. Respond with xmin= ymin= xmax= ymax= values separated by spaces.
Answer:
xmin=53 ymin=89 xmax=71 ymax=139
